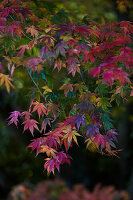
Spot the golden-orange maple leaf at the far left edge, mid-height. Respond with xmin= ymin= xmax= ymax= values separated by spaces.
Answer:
xmin=0 ymin=73 xmax=15 ymax=92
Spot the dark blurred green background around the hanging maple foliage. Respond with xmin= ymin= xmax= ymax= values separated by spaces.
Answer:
xmin=0 ymin=0 xmax=133 ymax=199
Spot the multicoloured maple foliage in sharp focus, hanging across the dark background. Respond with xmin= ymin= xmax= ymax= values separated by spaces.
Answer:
xmin=0 ymin=0 xmax=133 ymax=174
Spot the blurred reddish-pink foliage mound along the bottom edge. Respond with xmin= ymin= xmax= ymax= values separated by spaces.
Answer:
xmin=9 ymin=179 xmax=129 ymax=200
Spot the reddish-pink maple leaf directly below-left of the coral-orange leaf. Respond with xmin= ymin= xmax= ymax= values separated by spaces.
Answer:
xmin=22 ymin=119 xmax=39 ymax=136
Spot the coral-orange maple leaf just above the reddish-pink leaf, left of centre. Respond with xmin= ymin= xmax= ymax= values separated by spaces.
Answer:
xmin=31 ymin=101 xmax=47 ymax=118
